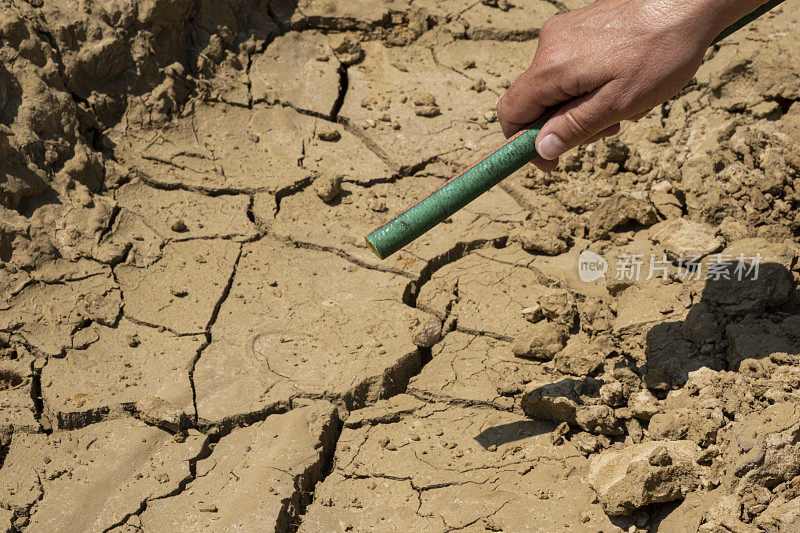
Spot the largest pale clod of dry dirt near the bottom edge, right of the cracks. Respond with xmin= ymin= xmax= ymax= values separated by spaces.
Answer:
xmin=588 ymin=440 xmax=703 ymax=516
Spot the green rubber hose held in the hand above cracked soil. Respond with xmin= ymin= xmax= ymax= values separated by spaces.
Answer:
xmin=365 ymin=0 xmax=783 ymax=259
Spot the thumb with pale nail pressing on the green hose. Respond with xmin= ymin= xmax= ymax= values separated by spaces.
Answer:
xmin=536 ymin=84 xmax=625 ymax=160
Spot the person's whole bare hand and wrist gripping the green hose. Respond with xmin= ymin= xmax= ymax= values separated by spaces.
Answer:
xmin=497 ymin=0 xmax=764 ymax=171
